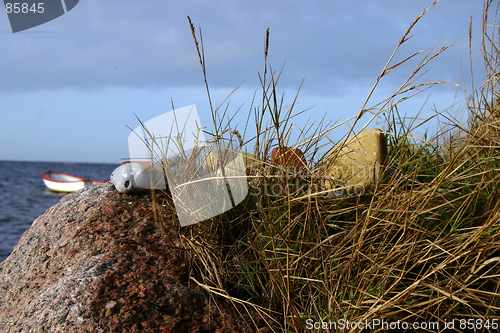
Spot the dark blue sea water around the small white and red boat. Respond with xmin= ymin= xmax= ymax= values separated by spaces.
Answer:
xmin=0 ymin=161 xmax=118 ymax=262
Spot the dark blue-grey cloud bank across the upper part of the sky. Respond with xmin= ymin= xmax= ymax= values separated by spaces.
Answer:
xmin=0 ymin=0 xmax=482 ymax=93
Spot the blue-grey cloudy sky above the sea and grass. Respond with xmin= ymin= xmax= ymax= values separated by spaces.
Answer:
xmin=0 ymin=0 xmax=492 ymax=164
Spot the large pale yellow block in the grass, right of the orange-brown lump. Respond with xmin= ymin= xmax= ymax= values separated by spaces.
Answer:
xmin=319 ymin=128 xmax=387 ymax=189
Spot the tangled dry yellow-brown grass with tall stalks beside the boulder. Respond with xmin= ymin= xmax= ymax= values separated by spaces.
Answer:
xmin=148 ymin=0 xmax=500 ymax=332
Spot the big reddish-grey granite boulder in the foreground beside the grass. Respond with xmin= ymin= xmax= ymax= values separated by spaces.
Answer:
xmin=0 ymin=182 xmax=264 ymax=332
